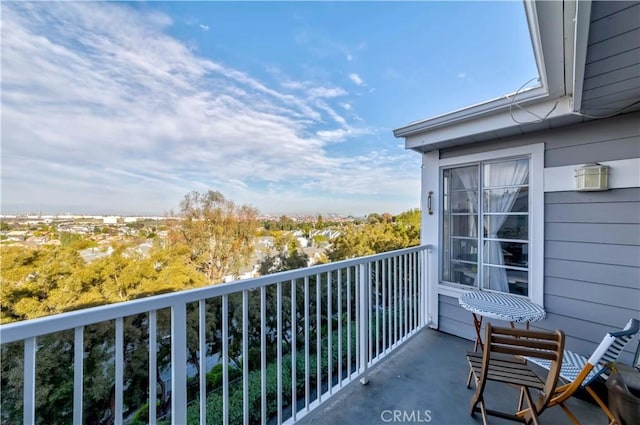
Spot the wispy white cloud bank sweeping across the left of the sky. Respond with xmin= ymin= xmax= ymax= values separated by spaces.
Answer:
xmin=0 ymin=2 xmax=419 ymax=214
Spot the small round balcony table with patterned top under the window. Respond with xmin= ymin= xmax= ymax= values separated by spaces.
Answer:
xmin=458 ymin=291 xmax=546 ymax=351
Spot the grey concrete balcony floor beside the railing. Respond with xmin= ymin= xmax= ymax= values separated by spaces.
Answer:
xmin=298 ymin=329 xmax=607 ymax=425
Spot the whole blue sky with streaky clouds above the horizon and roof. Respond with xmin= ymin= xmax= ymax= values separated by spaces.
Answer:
xmin=0 ymin=1 xmax=537 ymax=215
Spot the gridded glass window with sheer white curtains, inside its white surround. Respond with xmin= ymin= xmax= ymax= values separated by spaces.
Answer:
xmin=440 ymin=155 xmax=532 ymax=296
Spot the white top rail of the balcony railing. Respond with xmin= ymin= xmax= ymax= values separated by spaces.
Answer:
xmin=0 ymin=245 xmax=431 ymax=344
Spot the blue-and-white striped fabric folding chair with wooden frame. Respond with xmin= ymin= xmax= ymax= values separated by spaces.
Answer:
xmin=527 ymin=319 xmax=640 ymax=424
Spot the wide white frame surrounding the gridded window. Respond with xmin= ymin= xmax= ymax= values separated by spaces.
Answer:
xmin=437 ymin=143 xmax=544 ymax=305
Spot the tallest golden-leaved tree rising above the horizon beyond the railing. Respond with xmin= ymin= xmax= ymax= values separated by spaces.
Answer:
xmin=172 ymin=190 xmax=258 ymax=283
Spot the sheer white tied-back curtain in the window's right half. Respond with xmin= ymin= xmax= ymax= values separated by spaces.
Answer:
xmin=484 ymin=160 xmax=529 ymax=292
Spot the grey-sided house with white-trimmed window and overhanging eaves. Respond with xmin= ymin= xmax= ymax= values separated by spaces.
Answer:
xmin=394 ymin=1 xmax=640 ymax=356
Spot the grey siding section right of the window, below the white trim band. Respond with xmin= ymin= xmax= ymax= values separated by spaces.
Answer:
xmin=541 ymin=188 xmax=640 ymax=359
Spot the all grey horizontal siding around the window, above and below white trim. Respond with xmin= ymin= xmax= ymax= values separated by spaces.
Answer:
xmin=439 ymin=113 xmax=640 ymax=361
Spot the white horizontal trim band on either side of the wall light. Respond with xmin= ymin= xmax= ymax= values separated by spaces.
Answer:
xmin=544 ymin=158 xmax=640 ymax=192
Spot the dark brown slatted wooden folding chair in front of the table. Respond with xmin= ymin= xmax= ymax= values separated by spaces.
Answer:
xmin=467 ymin=323 xmax=564 ymax=425
